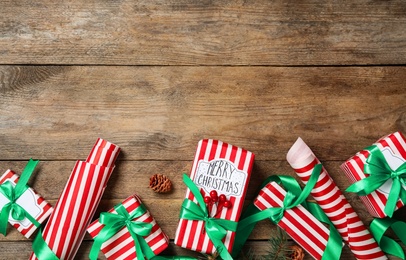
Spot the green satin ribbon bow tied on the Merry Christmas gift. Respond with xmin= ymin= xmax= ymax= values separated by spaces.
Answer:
xmin=180 ymin=174 xmax=237 ymax=260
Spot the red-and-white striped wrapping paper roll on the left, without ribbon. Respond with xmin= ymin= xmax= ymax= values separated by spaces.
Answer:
xmin=30 ymin=138 xmax=120 ymax=259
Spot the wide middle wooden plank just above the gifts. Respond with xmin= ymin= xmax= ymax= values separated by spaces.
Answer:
xmin=0 ymin=66 xmax=406 ymax=160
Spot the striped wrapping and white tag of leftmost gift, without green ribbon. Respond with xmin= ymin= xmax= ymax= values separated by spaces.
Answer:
xmin=0 ymin=170 xmax=53 ymax=238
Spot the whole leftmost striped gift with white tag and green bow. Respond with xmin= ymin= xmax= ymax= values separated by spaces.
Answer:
xmin=0 ymin=160 xmax=53 ymax=238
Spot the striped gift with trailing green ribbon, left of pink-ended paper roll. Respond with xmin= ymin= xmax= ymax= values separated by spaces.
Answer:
xmin=233 ymin=164 xmax=343 ymax=260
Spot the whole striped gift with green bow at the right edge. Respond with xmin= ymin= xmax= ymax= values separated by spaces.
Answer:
xmin=341 ymin=132 xmax=406 ymax=218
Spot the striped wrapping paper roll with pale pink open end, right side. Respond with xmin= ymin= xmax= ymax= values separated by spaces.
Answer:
xmin=287 ymin=138 xmax=387 ymax=260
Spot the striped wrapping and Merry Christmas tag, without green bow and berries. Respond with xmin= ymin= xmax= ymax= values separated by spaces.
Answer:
xmin=175 ymin=139 xmax=254 ymax=254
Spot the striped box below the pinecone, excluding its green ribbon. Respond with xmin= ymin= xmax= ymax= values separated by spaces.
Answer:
xmin=87 ymin=195 xmax=169 ymax=260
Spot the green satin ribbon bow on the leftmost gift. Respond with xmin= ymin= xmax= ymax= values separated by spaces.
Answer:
xmin=0 ymin=159 xmax=40 ymax=235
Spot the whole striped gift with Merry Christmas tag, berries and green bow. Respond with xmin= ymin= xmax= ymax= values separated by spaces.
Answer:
xmin=175 ymin=139 xmax=254 ymax=259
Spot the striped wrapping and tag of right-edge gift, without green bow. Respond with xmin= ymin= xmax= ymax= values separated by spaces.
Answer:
xmin=341 ymin=132 xmax=406 ymax=218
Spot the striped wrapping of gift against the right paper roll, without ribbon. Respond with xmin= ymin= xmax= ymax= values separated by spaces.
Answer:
xmin=254 ymin=182 xmax=330 ymax=259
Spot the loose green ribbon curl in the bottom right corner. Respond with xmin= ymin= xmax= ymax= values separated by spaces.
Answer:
xmin=370 ymin=217 xmax=406 ymax=259
